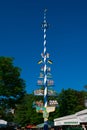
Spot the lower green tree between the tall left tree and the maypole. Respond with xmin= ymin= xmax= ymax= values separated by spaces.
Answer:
xmin=14 ymin=94 xmax=43 ymax=126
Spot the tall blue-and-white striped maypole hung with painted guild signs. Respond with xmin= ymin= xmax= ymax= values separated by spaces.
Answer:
xmin=33 ymin=9 xmax=58 ymax=130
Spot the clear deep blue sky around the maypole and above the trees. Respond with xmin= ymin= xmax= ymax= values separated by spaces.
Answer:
xmin=0 ymin=0 xmax=87 ymax=93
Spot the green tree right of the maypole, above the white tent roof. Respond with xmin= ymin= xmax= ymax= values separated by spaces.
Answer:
xmin=58 ymin=88 xmax=85 ymax=116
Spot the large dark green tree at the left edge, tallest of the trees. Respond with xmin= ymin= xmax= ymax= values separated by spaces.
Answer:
xmin=0 ymin=57 xmax=25 ymax=119
